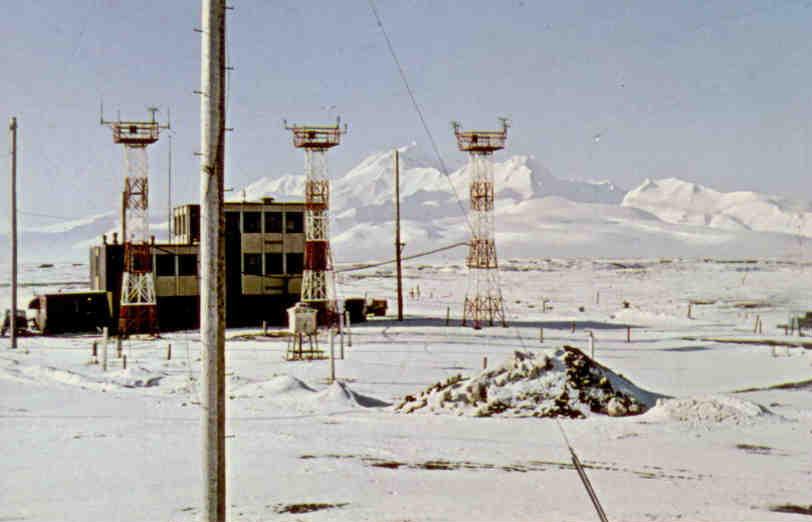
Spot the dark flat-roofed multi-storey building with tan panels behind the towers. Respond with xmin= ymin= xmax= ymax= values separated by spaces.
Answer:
xmin=90 ymin=198 xmax=304 ymax=331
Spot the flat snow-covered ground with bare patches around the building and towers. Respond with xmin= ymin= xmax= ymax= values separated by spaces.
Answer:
xmin=0 ymin=254 xmax=812 ymax=521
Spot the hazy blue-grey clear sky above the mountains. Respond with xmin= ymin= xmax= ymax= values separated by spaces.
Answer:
xmin=0 ymin=0 xmax=812 ymax=228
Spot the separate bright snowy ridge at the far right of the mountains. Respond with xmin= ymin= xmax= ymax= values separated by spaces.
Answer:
xmin=621 ymin=178 xmax=812 ymax=237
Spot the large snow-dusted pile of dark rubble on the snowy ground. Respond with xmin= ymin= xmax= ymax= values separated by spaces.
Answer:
xmin=395 ymin=346 xmax=658 ymax=418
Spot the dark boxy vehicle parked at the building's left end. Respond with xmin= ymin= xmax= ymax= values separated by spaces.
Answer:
xmin=28 ymin=292 xmax=111 ymax=334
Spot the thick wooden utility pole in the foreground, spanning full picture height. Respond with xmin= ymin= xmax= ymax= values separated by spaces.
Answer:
xmin=199 ymin=0 xmax=226 ymax=522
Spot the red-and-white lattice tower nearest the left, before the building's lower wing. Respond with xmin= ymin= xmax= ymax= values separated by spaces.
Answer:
xmin=101 ymin=107 xmax=169 ymax=337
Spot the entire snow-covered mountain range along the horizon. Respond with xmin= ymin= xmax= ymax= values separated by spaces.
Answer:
xmin=0 ymin=144 xmax=812 ymax=262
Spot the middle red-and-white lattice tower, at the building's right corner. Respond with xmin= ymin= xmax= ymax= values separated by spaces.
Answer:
xmin=285 ymin=118 xmax=347 ymax=325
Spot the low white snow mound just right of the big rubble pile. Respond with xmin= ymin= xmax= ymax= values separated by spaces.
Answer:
xmin=646 ymin=395 xmax=775 ymax=424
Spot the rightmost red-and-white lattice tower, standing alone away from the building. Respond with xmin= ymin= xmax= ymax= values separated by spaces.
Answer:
xmin=451 ymin=118 xmax=509 ymax=329
